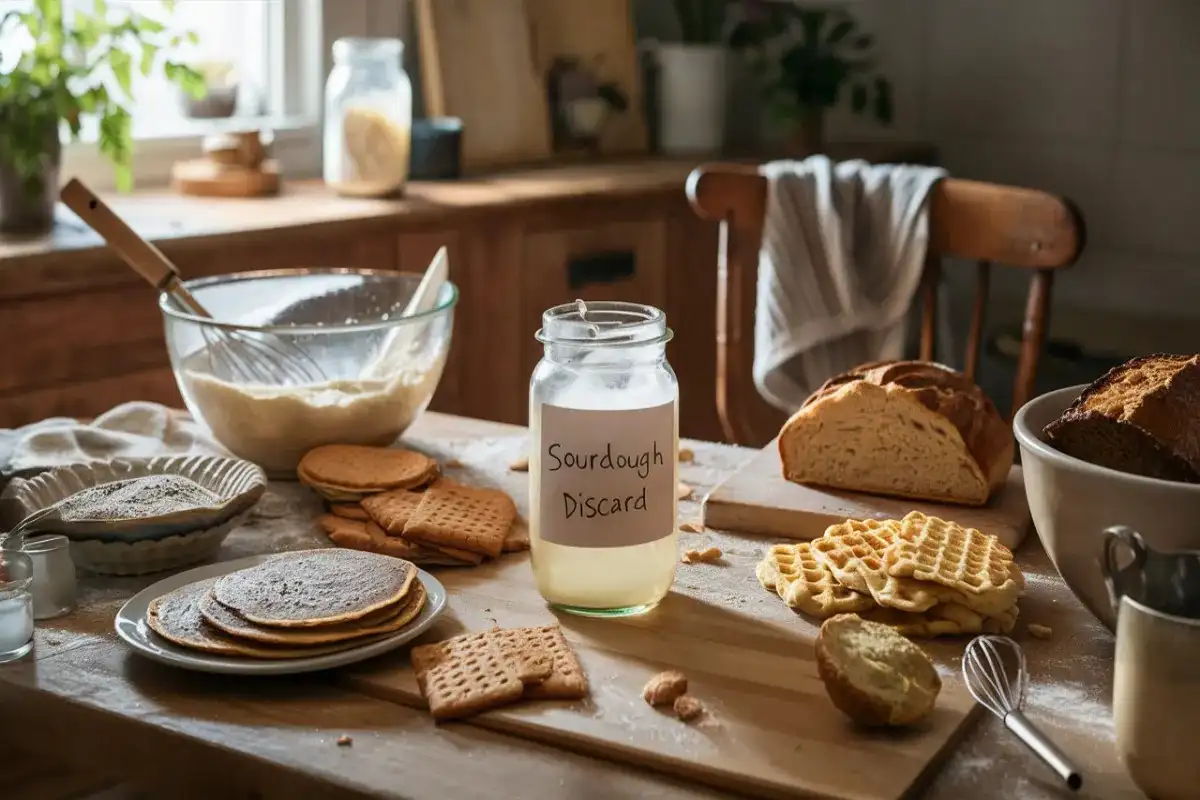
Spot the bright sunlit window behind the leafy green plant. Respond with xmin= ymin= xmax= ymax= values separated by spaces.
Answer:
xmin=0 ymin=0 xmax=323 ymax=188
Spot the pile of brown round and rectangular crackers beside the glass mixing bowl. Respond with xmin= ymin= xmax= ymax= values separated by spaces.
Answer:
xmin=296 ymin=445 xmax=529 ymax=567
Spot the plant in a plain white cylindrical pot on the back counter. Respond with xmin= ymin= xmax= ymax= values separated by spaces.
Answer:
xmin=656 ymin=0 xmax=731 ymax=155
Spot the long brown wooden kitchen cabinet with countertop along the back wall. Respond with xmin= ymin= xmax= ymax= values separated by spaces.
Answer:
xmin=0 ymin=146 xmax=928 ymax=439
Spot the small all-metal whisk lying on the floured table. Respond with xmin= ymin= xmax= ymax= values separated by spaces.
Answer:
xmin=962 ymin=636 xmax=1084 ymax=790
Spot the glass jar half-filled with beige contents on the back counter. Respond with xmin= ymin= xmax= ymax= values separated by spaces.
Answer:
xmin=324 ymin=38 xmax=413 ymax=197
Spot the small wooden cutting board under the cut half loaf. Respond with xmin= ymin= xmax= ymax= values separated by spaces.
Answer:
xmin=704 ymin=441 xmax=1033 ymax=549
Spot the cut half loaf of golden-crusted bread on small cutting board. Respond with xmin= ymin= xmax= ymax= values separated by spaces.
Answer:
xmin=779 ymin=361 xmax=1013 ymax=506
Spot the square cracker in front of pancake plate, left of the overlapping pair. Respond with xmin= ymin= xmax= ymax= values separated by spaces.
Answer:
xmin=412 ymin=633 xmax=524 ymax=720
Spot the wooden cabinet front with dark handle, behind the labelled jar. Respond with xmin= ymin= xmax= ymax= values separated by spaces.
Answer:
xmin=520 ymin=218 xmax=670 ymax=391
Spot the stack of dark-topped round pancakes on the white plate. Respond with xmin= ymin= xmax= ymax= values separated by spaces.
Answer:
xmin=146 ymin=549 xmax=426 ymax=658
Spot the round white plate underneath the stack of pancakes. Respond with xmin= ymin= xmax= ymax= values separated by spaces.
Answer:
xmin=115 ymin=555 xmax=446 ymax=675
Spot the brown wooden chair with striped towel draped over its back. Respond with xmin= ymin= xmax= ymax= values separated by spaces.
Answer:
xmin=688 ymin=164 xmax=1085 ymax=445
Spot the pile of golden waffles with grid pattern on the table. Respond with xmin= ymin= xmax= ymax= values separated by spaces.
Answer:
xmin=757 ymin=511 xmax=1025 ymax=637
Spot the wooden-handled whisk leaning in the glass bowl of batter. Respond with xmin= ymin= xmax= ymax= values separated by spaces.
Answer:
xmin=61 ymin=179 xmax=326 ymax=384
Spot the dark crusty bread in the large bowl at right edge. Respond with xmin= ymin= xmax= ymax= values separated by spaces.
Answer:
xmin=1043 ymin=354 xmax=1200 ymax=483
